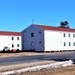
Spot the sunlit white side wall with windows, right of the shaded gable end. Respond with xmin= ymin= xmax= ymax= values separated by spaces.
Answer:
xmin=44 ymin=30 xmax=75 ymax=51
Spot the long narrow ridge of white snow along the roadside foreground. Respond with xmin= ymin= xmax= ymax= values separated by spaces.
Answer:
xmin=0 ymin=60 xmax=73 ymax=75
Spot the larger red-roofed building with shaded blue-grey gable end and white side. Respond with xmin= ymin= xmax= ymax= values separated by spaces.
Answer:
xmin=22 ymin=24 xmax=75 ymax=51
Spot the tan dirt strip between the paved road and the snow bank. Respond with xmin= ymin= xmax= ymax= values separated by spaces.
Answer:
xmin=0 ymin=61 xmax=56 ymax=72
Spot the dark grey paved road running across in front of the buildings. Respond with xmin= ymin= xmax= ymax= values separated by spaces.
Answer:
xmin=0 ymin=52 xmax=75 ymax=66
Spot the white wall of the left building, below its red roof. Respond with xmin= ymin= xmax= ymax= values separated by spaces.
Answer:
xmin=0 ymin=35 xmax=22 ymax=50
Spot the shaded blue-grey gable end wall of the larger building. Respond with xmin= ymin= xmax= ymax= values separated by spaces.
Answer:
xmin=22 ymin=25 xmax=44 ymax=51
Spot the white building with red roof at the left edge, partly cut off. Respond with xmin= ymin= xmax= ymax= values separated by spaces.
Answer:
xmin=0 ymin=31 xmax=22 ymax=51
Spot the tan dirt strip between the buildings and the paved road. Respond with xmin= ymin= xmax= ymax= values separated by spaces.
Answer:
xmin=0 ymin=52 xmax=74 ymax=58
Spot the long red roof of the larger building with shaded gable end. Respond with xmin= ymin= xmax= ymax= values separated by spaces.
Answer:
xmin=34 ymin=24 xmax=75 ymax=32
